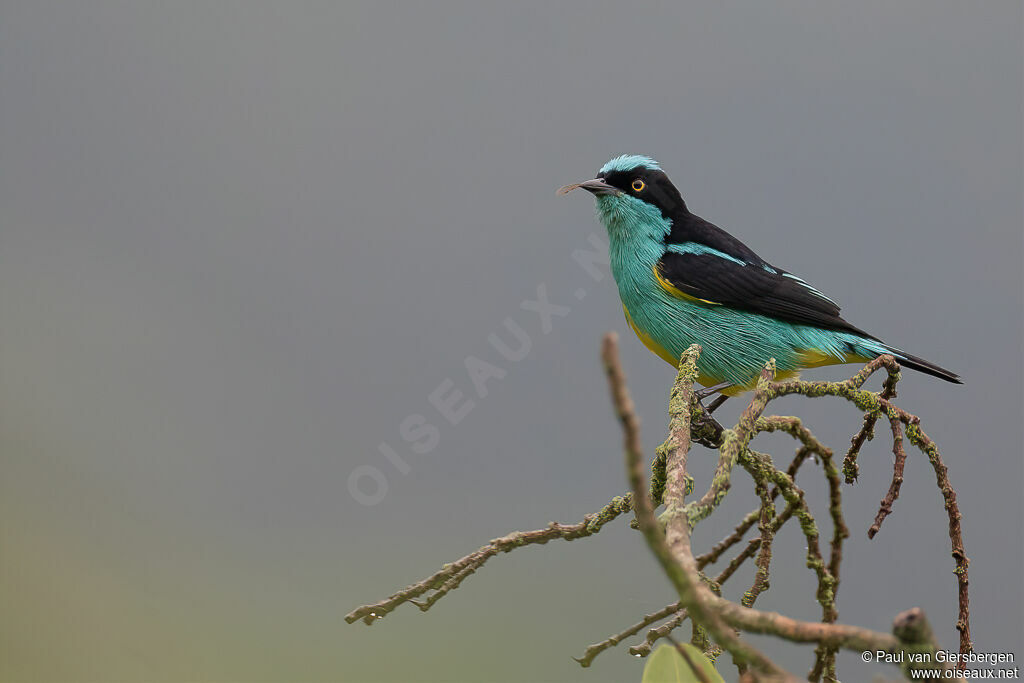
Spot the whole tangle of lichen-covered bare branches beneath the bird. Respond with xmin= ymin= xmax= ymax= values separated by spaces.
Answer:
xmin=345 ymin=334 xmax=971 ymax=681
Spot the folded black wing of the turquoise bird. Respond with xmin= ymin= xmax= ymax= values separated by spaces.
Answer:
xmin=655 ymin=251 xmax=874 ymax=339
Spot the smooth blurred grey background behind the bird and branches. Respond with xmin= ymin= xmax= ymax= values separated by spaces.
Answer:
xmin=0 ymin=0 xmax=1024 ymax=682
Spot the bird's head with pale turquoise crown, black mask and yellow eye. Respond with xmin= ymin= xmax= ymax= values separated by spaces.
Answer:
xmin=558 ymin=155 xmax=687 ymax=237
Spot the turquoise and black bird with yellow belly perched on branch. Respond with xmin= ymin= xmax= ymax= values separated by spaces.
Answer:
xmin=558 ymin=156 xmax=961 ymax=396
